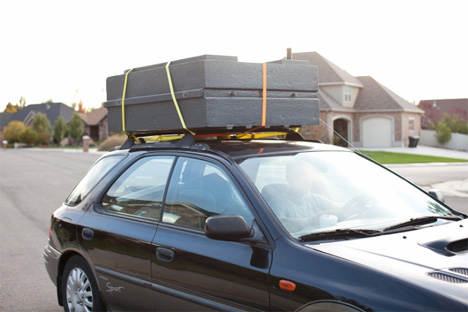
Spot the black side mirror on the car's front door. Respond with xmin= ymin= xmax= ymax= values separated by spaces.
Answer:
xmin=205 ymin=215 xmax=252 ymax=242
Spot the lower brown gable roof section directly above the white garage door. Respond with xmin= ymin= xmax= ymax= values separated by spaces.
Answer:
xmin=354 ymin=76 xmax=423 ymax=114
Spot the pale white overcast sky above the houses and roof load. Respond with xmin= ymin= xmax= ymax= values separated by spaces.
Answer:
xmin=0 ymin=0 xmax=468 ymax=111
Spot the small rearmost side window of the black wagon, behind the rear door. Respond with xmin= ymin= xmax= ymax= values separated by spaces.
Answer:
xmin=65 ymin=156 xmax=124 ymax=205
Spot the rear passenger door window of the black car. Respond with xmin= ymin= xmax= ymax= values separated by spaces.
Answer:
xmin=102 ymin=156 xmax=174 ymax=221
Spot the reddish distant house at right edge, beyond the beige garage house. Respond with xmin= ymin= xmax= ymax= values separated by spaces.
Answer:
xmin=418 ymin=99 xmax=468 ymax=129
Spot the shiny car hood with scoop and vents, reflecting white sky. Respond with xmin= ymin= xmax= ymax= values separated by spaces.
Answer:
xmin=307 ymin=219 xmax=468 ymax=302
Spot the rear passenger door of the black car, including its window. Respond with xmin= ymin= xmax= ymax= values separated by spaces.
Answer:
xmin=78 ymin=156 xmax=174 ymax=311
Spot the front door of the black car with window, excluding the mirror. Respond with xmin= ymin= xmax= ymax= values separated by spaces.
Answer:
xmin=152 ymin=157 xmax=271 ymax=310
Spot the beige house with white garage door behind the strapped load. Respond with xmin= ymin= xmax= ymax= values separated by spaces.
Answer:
xmin=292 ymin=52 xmax=424 ymax=147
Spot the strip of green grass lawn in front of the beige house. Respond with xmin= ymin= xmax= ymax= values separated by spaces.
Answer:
xmin=359 ymin=151 xmax=468 ymax=164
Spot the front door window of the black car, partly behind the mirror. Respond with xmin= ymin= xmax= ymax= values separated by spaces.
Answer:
xmin=163 ymin=157 xmax=253 ymax=229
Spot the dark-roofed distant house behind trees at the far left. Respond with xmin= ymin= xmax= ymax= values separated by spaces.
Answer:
xmin=0 ymin=103 xmax=75 ymax=138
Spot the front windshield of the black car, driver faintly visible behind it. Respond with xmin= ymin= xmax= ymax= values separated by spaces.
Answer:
xmin=239 ymin=151 xmax=454 ymax=238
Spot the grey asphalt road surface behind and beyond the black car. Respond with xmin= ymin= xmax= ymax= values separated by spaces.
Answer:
xmin=0 ymin=149 xmax=468 ymax=311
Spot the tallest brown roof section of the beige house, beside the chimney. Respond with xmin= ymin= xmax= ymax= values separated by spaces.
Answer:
xmin=292 ymin=52 xmax=362 ymax=88
